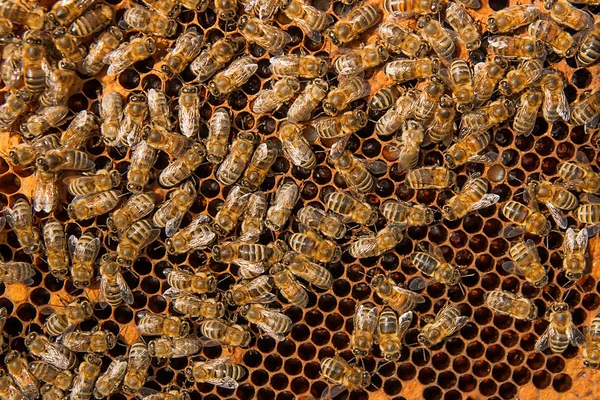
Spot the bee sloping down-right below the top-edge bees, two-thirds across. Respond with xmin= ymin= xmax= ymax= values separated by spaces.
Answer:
xmin=378 ymin=15 xmax=429 ymax=58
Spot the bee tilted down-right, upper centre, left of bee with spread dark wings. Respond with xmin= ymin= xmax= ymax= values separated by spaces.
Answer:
xmin=277 ymin=121 xmax=317 ymax=169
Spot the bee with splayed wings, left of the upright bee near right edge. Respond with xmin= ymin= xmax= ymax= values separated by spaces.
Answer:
xmin=502 ymin=239 xmax=548 ymax=288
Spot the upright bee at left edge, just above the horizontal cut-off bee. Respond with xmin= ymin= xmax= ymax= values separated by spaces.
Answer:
xmin=4 ymin=198 xmax=42 ymax=254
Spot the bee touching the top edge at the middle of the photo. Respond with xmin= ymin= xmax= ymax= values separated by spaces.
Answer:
xmin=280 ymin=0 xmax=333 ymax=41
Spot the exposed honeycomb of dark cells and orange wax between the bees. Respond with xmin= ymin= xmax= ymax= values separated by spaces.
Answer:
xmin=0 ymin=0 xmax=600 ymax=400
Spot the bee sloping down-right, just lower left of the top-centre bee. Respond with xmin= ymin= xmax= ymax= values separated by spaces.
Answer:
xmin=238 ymin=14 xmax=292 ymax=55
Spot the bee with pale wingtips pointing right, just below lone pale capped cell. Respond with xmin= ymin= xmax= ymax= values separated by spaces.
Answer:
xmin=442 ymin=173 xmax=500 ymax=221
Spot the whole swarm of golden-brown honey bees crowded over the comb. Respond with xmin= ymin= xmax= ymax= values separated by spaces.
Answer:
xmin=0 ymin=0 xmax=600 ymax=399
